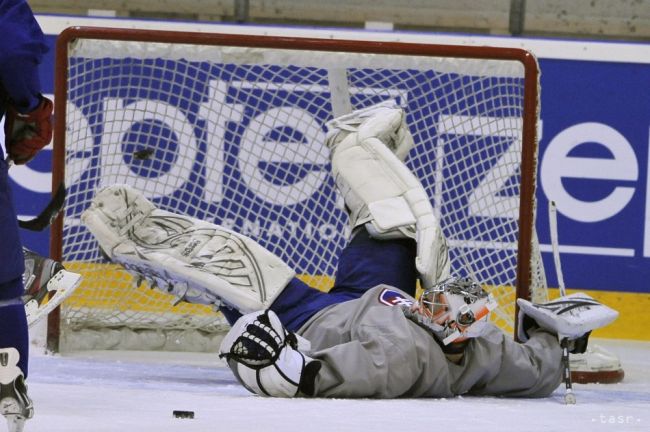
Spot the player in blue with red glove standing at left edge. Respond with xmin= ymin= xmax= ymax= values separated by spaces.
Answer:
xmin=0 ymin=0 xmax=52 ymax=432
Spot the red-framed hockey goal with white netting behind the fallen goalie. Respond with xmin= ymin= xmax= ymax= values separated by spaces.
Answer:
xmin=50 ymin=28 xmax=545 ymax=350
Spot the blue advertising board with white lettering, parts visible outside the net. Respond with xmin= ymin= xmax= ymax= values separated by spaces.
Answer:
xmin=11 ymin=27 xmax=650 ymax=292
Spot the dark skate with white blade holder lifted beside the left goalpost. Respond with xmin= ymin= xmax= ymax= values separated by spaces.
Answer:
xmin=23 ymin=248 xmax=81 ymax=327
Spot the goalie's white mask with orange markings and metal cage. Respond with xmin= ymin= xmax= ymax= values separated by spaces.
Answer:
xmin=404 ymin=277 xmax=498 ymax=345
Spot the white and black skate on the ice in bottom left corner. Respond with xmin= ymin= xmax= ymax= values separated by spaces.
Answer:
xmin=0 ymin=348 xmax=34 ymax=432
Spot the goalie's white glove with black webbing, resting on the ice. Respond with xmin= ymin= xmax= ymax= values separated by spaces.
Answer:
xmin=219 ymin=310 xmax=321 ymax=397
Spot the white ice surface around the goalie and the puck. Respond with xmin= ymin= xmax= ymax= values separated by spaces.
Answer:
xmin=13 ymin=340 xmax=650 ymax=432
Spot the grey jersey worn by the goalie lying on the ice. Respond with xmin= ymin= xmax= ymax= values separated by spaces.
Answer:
xmin=298 ymin=285 xmax=561 ymax=398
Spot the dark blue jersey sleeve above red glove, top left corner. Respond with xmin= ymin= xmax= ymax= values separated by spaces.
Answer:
xmin=0 ymin=0 xmax=48 ymax=112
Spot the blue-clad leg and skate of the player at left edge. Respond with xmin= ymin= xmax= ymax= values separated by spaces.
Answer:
xmin=0 ymin=159 xmax=33 ymax=430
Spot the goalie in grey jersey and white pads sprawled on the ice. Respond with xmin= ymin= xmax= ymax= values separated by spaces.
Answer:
xmin=82 ymin=101 xmax=617 ymax=398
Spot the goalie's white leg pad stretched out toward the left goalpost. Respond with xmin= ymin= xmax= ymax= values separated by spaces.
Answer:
xmin=82 ymin=185 xmax=295 ymax=313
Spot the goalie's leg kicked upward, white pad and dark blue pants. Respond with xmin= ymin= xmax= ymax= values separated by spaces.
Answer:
xmin=327 ymin=103 xmax=449 ymax=298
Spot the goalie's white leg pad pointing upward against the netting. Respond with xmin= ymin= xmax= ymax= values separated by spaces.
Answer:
xmin=327 ymin=106 xmax=450 ymax=288
